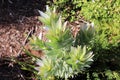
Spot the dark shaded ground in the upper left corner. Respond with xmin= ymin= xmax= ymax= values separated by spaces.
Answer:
xmin=0 ymin=0 xmax=50 ymax=22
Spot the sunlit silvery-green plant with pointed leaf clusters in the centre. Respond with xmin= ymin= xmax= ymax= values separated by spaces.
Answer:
xmin=31 ymin=6 xmax=93 ymax=80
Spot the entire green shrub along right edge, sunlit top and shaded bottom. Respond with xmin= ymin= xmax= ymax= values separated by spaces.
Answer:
xmin=77 ymin=0 xmax=120 ymax=80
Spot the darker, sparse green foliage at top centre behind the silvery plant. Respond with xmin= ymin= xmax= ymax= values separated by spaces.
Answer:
xmin=48 ymin=0 xmax=84 ymax=21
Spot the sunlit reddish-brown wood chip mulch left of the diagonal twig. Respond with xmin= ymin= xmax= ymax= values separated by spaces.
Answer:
xmin=0 ymin=17 xmax=41 ymax=57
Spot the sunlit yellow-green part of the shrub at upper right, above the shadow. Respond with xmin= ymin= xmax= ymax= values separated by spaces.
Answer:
xmin=81 ymin=0 xmax=120 ymax=47
